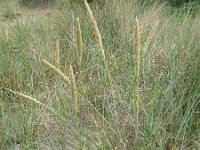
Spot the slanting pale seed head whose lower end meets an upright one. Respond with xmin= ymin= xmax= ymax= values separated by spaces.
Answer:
xmin=42 ymin=60 xmax=71 ymax=84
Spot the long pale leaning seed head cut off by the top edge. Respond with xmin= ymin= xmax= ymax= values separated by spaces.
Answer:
xmin=84 ymin=0 xmax=106 ymax=61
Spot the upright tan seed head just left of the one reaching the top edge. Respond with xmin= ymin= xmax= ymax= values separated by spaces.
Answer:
xmin=76 ymin=18 xmax=83 ymax=68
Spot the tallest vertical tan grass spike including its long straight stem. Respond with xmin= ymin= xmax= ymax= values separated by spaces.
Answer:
xmin=135 ymin=17 xmax=141 ymax=143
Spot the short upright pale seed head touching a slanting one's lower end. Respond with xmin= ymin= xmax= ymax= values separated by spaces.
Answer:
xmin=70 ymin=65 xmax=78 ymax=114
